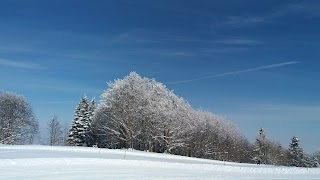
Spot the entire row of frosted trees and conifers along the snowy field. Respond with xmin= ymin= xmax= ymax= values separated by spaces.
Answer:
xmin=0 ymin=72 xmax=320 ymax=167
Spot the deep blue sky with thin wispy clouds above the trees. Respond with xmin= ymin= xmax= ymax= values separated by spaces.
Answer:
xmin=0 ymin=0 xmax=320 ymax=152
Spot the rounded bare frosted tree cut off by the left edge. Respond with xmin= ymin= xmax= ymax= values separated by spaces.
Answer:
xmin=0 ymin=92 xmax=38 ymax=144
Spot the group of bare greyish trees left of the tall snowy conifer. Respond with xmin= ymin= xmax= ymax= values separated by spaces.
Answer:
xmin=0 ymin=92 xmax=66 ymax=146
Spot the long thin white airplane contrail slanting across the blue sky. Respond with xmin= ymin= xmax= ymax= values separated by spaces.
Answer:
xmin=168 ymin=61 xmax=300 ymax=84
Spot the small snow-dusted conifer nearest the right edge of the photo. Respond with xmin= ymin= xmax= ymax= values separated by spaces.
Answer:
xmin=288 ymin=136 xmax=305 ymax=167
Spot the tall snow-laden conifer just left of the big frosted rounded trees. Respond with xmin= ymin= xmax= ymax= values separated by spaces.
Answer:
xmin=67 ymin=96 xmax=92 ymax=146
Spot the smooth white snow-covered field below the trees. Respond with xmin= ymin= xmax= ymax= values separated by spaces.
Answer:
xmin=0 ymin=145 xmax=320 ymax=180
